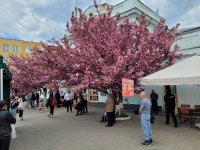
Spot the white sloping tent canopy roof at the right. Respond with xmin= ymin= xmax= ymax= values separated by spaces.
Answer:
xmin=140 ymin=55 xmax=200 ymax=85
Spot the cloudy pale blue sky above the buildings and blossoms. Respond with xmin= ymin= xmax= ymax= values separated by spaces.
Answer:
xmin=0 ymin=0 xmax=200 ymax=42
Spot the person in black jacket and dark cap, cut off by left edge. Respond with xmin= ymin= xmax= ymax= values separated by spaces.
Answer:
xmin=0 ymin=101 xmax=16 ymax=150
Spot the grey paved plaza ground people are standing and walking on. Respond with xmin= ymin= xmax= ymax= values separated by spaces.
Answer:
xmin=10 ymin=108 xmax=200 ymax=150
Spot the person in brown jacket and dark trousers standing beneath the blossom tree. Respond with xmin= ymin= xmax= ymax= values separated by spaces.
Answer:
xmin=104 ymin=94 xmax=115 ymax=127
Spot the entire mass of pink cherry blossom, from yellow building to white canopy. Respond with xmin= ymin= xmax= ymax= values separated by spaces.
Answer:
xmin=11 ymin=1 xmax=182 ymax=96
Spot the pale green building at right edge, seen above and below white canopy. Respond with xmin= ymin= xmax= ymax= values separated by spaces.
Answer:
xmin=172 ymin=26 xmax=200 ymax=107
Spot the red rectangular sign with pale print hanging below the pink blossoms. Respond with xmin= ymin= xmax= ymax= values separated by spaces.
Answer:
xmin=122 ymin=78 xmax=134 ymax=97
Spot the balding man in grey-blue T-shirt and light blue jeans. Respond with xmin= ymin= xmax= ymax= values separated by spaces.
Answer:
xmin=139 ymin=91 xmax=153 ymax=145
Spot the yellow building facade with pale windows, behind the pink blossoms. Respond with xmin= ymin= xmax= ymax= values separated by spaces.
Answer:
xmin=0 ymin=38 xmax=42 ymax=59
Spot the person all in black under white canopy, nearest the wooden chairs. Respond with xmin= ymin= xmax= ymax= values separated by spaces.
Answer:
xmin=164 ymin=89 xmax=178 ymax=128
